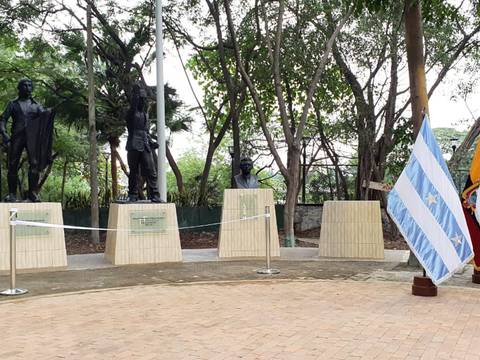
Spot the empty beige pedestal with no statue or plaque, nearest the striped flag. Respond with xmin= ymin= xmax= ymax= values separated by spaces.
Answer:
xmin=318 ymin=201 xmax=384 ymax=259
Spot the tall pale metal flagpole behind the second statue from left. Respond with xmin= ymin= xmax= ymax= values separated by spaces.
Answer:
xmin=155 ymin=0 xmax=167 ymax=202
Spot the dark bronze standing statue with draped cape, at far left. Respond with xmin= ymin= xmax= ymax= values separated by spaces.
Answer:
xmin=0 ymin=79 xmax=54 ymax=202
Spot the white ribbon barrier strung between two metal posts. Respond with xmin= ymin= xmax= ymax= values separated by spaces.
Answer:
xmin=10 ymin=214 xmax=270 ymax=233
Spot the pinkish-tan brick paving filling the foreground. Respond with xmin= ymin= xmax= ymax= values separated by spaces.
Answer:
xmin=0 ymin=280 xmax=480 ymax=360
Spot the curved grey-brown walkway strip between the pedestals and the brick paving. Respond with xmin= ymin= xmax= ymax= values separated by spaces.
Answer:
xmin=0 ymin=248 xmax=412 ymax=300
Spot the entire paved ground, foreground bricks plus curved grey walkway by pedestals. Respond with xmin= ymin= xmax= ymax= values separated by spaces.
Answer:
xmin=0 ymin=249 xmax=480 ymax=360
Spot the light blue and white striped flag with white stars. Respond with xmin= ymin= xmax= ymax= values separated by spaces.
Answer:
xmin=387 ymin=116 xmax=473 ymax=285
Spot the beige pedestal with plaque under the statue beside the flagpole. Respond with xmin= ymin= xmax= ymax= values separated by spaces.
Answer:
xmin=105 ymin=203 xmax=182 ymax=265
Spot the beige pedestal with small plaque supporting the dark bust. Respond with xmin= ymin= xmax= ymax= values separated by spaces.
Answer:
xmin=218 ymin=189 xmax=280 ymax=258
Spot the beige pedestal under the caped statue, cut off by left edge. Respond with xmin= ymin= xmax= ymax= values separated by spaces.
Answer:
xmin=0 ymin=202 xmax=67 ymax=270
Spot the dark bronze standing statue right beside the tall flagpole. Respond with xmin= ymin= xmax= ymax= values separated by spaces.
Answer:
xmin=126 ymin=85 xmax=161 ymax=202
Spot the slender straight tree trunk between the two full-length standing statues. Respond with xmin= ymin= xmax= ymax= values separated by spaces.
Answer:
xmin=87 ymin=2 xmax=100 ymax=244
